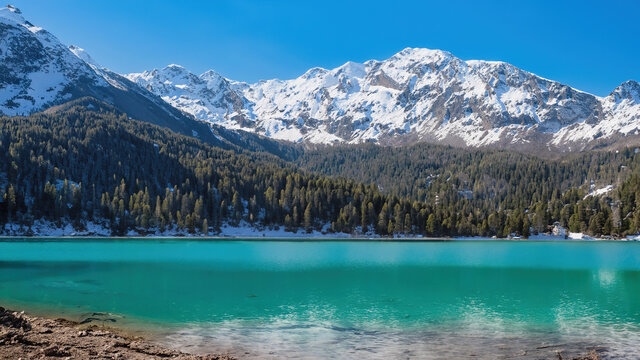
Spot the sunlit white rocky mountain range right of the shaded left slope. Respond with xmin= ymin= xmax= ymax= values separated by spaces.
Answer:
xmin=126 ymin=48 xmax=640 ymax=151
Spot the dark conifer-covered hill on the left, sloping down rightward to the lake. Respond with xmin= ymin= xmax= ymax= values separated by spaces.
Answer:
xmin=0 ymin=107 xmax=385 ymax=234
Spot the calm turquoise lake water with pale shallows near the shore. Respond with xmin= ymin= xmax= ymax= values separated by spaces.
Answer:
xmin=0 ymin=239 xmax=640 ymax=359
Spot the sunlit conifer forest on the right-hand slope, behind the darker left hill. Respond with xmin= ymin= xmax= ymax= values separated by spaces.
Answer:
xmin=295 ymin=144 xmax=640 ymax=236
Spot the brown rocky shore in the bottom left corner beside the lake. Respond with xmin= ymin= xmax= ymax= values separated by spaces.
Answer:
xmin=0 ymin=307 xmax=233 ymax=360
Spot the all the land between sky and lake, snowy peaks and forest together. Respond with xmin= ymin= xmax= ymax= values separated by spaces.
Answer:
xmin=0 ymin=6 xmax=640 ymax=237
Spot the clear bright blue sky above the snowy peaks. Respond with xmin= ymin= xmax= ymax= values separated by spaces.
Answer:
xmin=8 ymin=0 xmax=640 ymax=95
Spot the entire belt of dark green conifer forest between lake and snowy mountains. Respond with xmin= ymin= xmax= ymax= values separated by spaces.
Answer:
xmin=0 ymin=106 xmax=640 ymax=237
